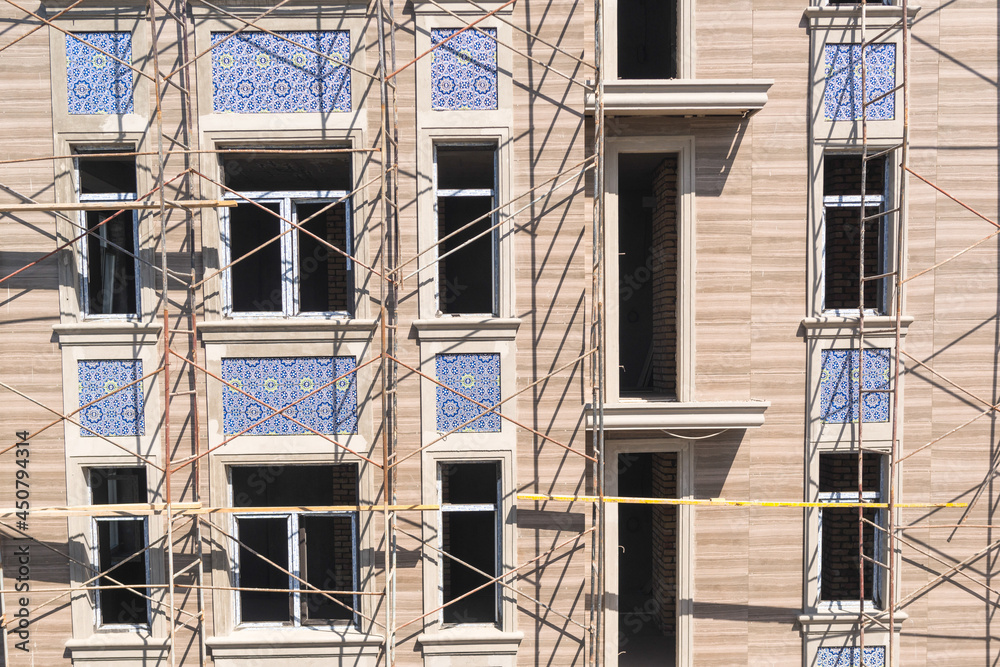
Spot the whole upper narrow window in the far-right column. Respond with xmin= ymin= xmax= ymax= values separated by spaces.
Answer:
xmin=823 ymin=153 xmax=889 ymax=313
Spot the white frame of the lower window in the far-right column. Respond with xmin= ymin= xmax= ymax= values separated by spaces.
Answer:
xmin=816 ymin=452 xmax=887 ymax=612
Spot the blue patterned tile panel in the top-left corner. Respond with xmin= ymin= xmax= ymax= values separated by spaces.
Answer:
xmin=66 ymin=32 xmax=134 ymax=115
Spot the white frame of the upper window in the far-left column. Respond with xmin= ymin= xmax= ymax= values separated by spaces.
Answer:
xmin=73 ymin=153 xmax=142 ymax=320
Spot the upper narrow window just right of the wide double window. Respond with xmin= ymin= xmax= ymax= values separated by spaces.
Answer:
xmin=434 ymin=144 xmax=500 ymax=315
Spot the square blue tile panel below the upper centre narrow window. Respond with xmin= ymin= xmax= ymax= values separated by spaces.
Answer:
xmin=436 ymin=354 xmax=500 ymax=433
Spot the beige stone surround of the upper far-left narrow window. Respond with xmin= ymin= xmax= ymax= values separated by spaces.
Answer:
xmin=53 ymin=130 xmax=159 ymax=324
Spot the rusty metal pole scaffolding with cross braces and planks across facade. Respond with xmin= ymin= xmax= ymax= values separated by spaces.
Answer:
xmin=0 ymin=0 xmax=1000 ymax=667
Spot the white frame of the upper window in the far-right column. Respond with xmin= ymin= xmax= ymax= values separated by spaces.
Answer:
xmin=817 ymin=149 xmax=895 ymax=317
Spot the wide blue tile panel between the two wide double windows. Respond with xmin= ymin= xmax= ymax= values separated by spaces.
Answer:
xmin=222 ymin=357 xmax=358 ymax=435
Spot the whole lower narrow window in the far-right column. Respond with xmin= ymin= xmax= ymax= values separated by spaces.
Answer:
xmin=819 ymin=452 xmax=884 ymax=606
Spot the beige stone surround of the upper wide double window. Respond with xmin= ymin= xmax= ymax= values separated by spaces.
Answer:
xmin=200 ymin=129 xmax=379 ymax=324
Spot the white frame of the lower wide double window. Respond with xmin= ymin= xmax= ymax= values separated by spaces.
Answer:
xmin=226 ymin=464 xmax=360 ymax=628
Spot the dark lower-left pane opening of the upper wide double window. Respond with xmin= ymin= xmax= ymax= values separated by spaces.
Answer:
xmin=229 ymin=202 xmax=282 ymax=313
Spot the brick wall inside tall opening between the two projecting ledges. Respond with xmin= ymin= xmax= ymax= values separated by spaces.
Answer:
xmin=651 ymin=155 xmax=677 ymax=396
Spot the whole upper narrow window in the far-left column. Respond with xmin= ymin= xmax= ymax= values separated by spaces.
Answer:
xmin=74 ymin=150 xmax=139 ymax=316
